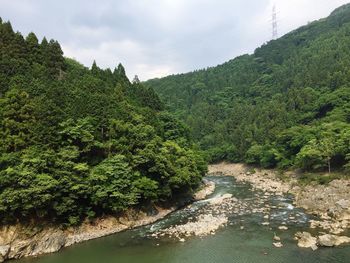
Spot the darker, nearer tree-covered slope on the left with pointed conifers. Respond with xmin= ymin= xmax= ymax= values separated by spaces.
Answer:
xmin=0 ymin=19 xmax=206 ymax=225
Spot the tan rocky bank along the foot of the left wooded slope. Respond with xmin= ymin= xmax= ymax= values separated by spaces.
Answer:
xmin=0 ymin=182 xmax=215 ymax=262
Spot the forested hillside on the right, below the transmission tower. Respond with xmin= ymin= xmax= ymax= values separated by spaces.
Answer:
xmin=146 ymin=4 xmax=350 ymax=174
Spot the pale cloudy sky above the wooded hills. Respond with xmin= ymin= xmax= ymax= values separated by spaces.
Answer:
xmin=0 ymin=0 xmax=350 ymax=80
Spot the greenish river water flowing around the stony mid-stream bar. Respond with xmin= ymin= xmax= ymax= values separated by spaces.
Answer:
xmin=14 ymin=177 xmax=350 ymax=263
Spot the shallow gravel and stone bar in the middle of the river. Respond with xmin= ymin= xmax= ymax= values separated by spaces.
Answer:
xmin=149 ymin=188 xmax=294 ymax=245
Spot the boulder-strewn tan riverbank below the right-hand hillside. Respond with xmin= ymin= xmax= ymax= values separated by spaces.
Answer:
xmin=209 ymin=163 xmax=350 ymax=252
